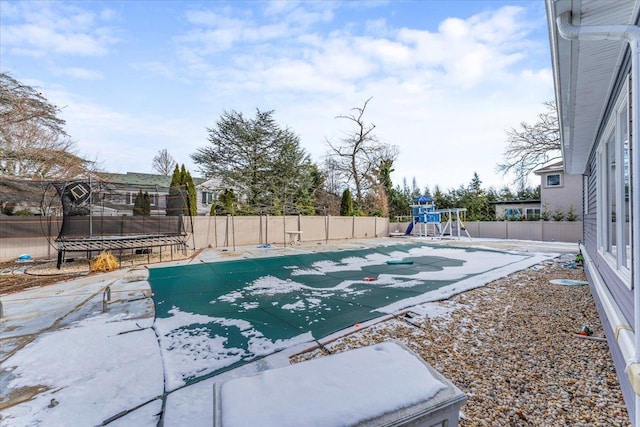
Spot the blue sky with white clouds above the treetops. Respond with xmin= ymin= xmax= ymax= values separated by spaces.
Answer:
xmin=0 ymin=0 xmax=553 ymax=190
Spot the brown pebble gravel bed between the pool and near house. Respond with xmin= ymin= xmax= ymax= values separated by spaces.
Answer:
xmin=293 ymin=259 xmax=631 ymax=427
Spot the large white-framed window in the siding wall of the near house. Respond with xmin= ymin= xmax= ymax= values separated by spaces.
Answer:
xmin=597 ymin=80 xmax=631 ymax=287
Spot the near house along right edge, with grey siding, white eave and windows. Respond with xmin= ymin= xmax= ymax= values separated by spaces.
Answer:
xmin=546 ymin=0 xmax=640 ymax=426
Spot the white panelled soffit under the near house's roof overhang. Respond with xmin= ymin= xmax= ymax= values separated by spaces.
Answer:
xmin=548 ymin=0 xmax=636 ymax=174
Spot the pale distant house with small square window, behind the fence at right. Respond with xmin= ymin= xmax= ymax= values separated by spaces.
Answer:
xmin=534 ymin=162 xmax=582 ymax=220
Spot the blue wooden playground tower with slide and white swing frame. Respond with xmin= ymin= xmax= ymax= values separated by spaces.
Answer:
xmin=405 ymin=196 xmax=471 ymax=239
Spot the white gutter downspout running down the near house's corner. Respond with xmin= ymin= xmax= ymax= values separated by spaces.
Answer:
xmin=556 ymin=12 xmax=640 ymax=426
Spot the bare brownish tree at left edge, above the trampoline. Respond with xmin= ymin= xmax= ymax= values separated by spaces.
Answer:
xmin=0 ymin=72 xmax=92 ymax=180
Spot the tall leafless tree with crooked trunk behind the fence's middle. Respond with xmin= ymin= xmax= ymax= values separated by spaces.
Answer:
xmin=327 ymin=98 xmax=398 ymax=209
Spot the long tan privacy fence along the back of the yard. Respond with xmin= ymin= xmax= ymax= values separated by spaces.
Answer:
xmin=0 ymin=216 xmax=582 ymax=261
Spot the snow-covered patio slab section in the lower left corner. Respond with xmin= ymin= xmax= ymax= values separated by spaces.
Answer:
xmin=0 ymin=314 xmax=164 ymax=426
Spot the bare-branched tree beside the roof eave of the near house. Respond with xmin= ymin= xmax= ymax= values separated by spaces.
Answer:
xmin=497 ymin=101 xmax=562 ymax=187
